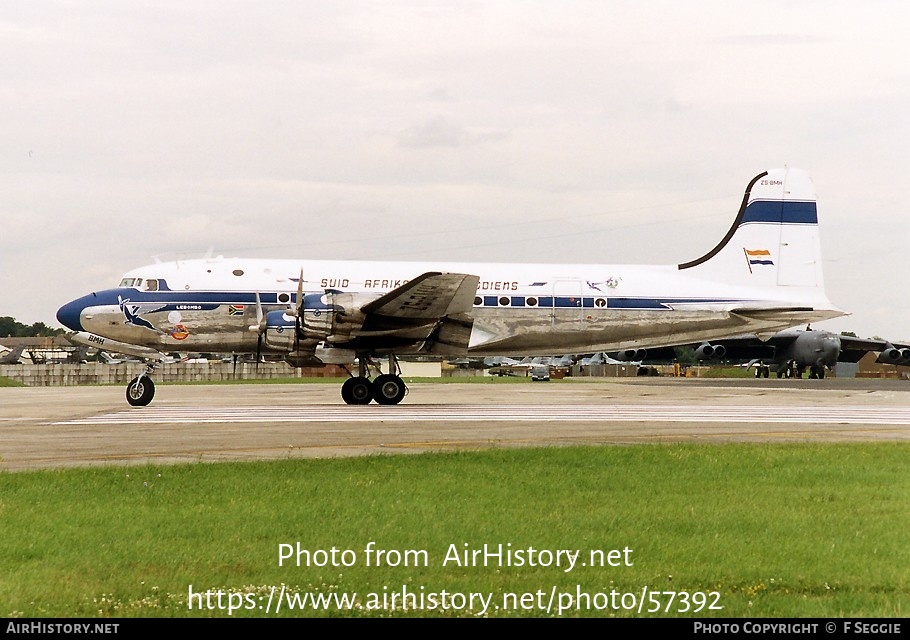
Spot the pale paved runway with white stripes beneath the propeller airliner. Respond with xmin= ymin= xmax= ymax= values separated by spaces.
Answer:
xmin=0 ymin=378 xmax=910 ymax=471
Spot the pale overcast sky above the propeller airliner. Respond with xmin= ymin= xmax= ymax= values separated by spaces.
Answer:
xmin=0 ymin=0 xmax=910 ymax=341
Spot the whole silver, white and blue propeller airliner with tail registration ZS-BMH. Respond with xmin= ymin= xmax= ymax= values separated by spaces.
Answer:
xmin=57 ymin=168 xmax=845 ymax=406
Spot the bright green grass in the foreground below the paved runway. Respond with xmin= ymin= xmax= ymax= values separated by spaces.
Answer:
xmin=0 ymin=443 xmax=910 ymax=617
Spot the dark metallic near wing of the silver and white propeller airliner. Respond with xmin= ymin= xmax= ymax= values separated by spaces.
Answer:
xmin=352 ymin=272 xmax=480 ymax=354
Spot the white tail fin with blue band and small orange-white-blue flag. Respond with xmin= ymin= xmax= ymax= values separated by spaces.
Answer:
xmin=679 ymin=168 xmax=824 ymax=289
